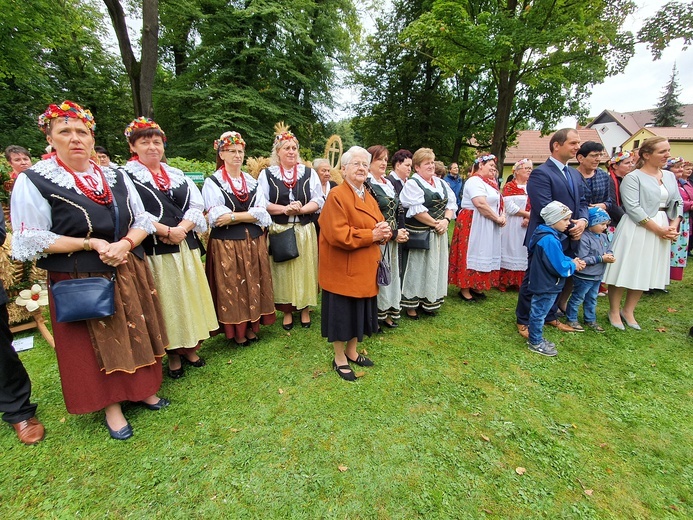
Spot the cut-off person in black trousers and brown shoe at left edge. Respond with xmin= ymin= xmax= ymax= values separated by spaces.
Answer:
xmin=0 ymin=207 xmax=44 ymax=444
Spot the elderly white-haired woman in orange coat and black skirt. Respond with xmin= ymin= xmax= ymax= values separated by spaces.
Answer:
xmin=318 ymin=146 xmax=392 ymax=381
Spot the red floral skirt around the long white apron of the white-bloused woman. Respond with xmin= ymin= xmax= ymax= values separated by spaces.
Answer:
xmin=448 ymin=209 xmax=500 ymax=291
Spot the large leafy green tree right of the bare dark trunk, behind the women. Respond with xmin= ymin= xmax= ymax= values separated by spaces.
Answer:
xmin=155 ymin=0 xmax=359 ymax=158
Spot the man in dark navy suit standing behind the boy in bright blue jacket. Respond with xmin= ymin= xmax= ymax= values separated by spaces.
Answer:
xmin=515 ymin=128 xmax=589 ymax=338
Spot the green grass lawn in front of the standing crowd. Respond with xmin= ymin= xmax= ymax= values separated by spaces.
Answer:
xmin=0 ymin=273 xmax=693 ymax=519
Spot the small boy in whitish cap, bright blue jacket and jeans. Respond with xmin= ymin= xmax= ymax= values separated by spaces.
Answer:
xmin=527 ymin=200 xmax=585 ymax=356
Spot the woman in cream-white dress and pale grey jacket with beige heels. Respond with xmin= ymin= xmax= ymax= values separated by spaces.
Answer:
xmin=604 ymin=137 xmax=683 ymax=330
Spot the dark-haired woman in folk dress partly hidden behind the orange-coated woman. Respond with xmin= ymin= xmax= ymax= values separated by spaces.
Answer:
xmin=366 ymin=145 xmax=409 ymax=329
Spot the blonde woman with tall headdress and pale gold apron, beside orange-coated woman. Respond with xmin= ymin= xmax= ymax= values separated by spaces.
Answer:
xmin=258 ymin=123 xmax=325 ymax=330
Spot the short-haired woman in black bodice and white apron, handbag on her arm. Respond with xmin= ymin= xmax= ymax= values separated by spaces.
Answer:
xmin=400 ymin=148 xmax=457 ymax=319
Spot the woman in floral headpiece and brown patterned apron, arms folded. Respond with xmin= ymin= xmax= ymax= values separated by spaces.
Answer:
xmin=202 ymin=132 xmax=275 ymax=345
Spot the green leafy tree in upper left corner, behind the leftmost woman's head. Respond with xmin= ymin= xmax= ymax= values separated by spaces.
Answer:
xmin=0 ymin=0 xmax=129 ymax=156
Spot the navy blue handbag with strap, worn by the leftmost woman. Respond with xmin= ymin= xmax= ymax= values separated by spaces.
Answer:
xmin=49 ymin=195 xmax=120 ymax=323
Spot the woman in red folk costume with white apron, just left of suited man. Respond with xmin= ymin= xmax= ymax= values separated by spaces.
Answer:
xmin=498 ymin=159 xmax=533 ymax=291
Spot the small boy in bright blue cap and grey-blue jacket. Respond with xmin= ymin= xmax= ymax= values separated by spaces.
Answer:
xmin=565 ymin=207 xmax=616 ymax=332
